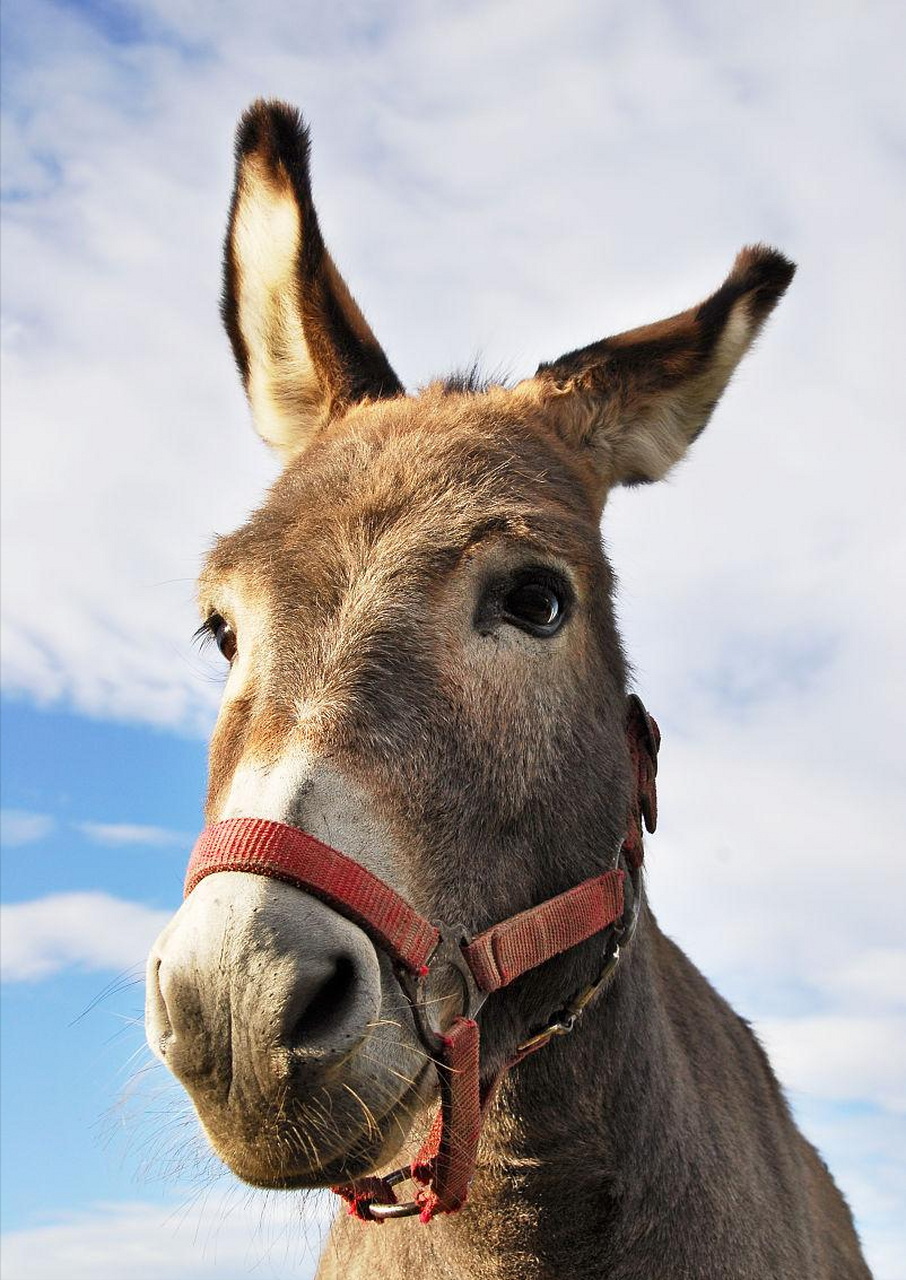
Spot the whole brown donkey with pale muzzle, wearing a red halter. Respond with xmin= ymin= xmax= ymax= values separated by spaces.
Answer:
xmin=146 ymin=102 xmax=869 ymax=1280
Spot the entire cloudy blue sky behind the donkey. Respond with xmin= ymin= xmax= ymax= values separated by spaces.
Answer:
xmin=0 ymin=0 xmax=906 ymax=1280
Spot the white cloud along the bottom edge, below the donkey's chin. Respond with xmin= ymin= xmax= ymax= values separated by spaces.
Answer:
xmin=3 ymin=1187 xmax=334 ymax=1280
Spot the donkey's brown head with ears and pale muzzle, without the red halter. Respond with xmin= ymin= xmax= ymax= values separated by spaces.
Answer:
xmin=147 ymin=102 xmax=793 ymax=1187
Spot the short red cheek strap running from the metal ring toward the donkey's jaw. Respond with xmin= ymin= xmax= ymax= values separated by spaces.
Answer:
xmin=463 ymin=870 xmax=623 ymax=991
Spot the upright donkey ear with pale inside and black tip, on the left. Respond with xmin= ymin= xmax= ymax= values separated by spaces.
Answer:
xmin=221 ymin=101 xmax=403 ymax=458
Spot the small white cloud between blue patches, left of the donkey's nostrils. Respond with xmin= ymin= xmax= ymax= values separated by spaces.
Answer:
xmin=0 ymin=892 xmax=171 ymax=982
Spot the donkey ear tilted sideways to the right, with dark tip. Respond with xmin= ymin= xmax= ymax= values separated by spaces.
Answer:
xmin=522 ymin=244 xmax=796 ymax=488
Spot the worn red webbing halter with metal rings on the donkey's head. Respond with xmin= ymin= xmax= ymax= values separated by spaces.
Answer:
xmin=186 ymin=695 xmax=660 ymax=1222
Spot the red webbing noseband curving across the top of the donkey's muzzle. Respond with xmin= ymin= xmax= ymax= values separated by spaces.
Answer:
xmin=184 ymin=818 xmax=440 ymax=974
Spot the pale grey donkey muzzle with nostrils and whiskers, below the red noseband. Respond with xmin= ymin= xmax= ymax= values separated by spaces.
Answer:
xmin=147 ymin=872 xmax=435 ymax=1188
